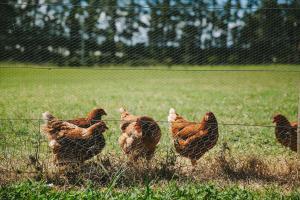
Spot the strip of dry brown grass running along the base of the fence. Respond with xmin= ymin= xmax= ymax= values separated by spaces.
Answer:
xmin=0 ymin=144 xmax=300 ymax=189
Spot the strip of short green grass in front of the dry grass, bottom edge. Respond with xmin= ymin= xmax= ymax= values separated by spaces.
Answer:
xmin=0 ymin=182 xmax=300 ymax=199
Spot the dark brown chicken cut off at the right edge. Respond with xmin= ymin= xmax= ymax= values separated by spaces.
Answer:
xmin=273 ymin=114 xmax=298 ymax=152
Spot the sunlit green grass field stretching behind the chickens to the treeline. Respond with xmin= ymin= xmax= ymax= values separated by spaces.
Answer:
xmin=0 ymin=64 xmax=300 ymax=198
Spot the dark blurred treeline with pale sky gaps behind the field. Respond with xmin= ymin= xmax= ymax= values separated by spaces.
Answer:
xmin=0 ymin=0 xmax=300 ymax=66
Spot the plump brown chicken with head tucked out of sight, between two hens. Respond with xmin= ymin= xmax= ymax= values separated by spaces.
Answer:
xmin=119 ymin=108 xmax=161 ymax=161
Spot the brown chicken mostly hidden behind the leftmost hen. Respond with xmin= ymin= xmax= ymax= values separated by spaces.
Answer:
xmin=67 ymin=108 xmax=107 ymax=128
